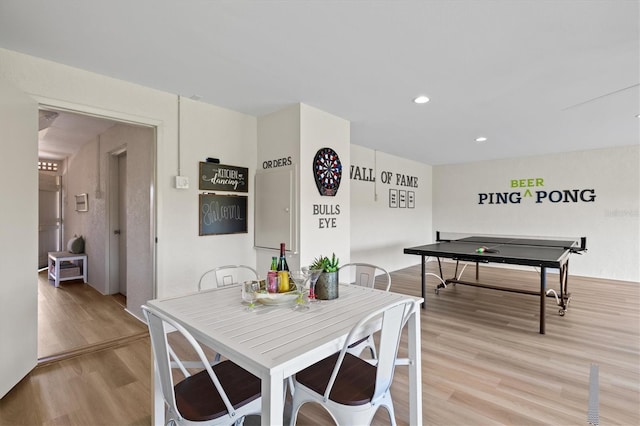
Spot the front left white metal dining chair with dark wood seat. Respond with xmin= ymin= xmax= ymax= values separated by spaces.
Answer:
xmin=142 ymin=305 xmax=262 ymax=425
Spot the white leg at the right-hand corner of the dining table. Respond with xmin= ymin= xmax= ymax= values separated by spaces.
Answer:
xmin=407 ymin=306 xmax=422 ymax=426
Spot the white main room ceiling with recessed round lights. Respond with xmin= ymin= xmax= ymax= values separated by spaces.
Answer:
xmin=0 ymin=0 xmax=640 ymax=165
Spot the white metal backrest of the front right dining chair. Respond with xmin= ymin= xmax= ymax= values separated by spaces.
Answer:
xmin=324 ymin=299 xmax=415 ymax=404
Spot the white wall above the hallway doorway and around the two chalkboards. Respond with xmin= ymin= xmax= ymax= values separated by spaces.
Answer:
xmin=0 ymin=49 xmax=256 ymax=297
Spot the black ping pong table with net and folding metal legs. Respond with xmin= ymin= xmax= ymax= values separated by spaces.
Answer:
xmin=404 ymin=231 xmax=587 ymax=334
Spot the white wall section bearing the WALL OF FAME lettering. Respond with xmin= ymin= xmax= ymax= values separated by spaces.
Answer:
xmin=345 ymin=145 xmax=433 ymax=271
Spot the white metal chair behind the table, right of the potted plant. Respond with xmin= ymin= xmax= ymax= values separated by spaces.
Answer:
xmin=340 ymin=262 xmax=391 ymax=359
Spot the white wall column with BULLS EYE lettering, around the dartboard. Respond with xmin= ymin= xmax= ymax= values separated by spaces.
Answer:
xmin=258 ymin=104 xmax=351 ymax=274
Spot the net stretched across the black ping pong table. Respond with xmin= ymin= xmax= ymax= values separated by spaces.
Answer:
xmin=436 ymin=231 xmax=587 ymax=254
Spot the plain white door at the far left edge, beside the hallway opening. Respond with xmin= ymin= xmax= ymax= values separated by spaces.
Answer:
xmin=0 ymin=80 xmax=38 ymax=398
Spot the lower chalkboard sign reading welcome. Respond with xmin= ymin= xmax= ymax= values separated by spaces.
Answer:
xmin=199 ymin=193 xmax=247 ymax=235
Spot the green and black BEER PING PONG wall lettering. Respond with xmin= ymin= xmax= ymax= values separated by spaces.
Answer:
xmin=478 ymin=177 xmax=596 ymax=205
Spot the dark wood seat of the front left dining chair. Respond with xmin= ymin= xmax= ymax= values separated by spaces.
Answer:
xmin=174 ymin=361 xmax=261 ymax=421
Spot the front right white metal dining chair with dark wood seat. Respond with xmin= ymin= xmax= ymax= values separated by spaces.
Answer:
xmin=290 ymin=299 xmax=415 ymax=426
